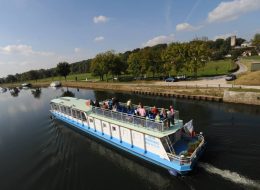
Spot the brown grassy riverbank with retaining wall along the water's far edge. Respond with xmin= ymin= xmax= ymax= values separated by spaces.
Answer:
xmin=5 ymin=81 xmax=260 ymax=105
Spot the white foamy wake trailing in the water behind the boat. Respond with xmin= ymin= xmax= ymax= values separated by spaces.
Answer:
xmin=198 ymin=163 xmax=260 ymax=189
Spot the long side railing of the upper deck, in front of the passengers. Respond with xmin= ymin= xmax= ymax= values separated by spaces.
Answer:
xmin=92 ymin=106 xmax=169 ymax=131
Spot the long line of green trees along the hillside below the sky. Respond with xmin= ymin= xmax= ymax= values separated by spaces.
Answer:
xmin=0 ymin=34 xmax=260 ymax=83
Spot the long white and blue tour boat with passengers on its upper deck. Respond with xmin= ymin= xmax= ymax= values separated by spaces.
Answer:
xmin=50 ymin=97 xmax=206 ymax=176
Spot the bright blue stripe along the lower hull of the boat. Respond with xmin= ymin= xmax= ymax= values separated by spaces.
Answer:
xmin=51 ymin=111 xmax=191 ymax=174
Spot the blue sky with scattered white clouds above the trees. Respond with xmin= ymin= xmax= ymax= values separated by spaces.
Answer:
xmin=0 ymin=0 xmax=260 ymax=77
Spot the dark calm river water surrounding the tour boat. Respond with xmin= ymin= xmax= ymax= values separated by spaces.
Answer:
xmin=0 ymin=88 xmax=260 ymax=190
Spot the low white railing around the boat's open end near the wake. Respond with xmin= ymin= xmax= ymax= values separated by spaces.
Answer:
xmin=167 ymin=134 xmax=205 ymax=165
